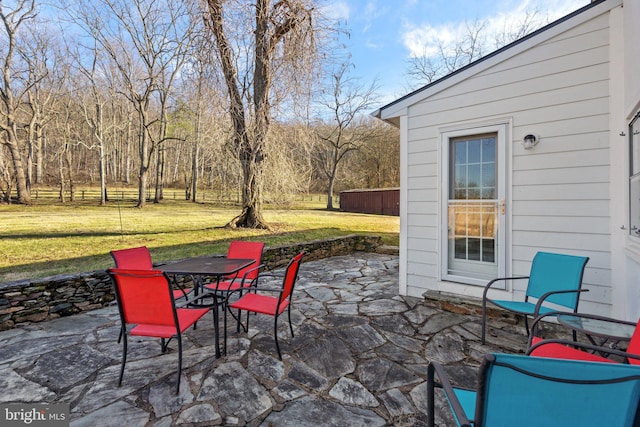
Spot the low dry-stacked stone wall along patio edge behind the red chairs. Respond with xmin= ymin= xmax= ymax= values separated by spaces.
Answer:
xmin=0 ymin=235 xmax=382 ymax=330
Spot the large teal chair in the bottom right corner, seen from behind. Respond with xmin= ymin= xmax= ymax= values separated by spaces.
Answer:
xmin=427 ymin=354 xmax=640 ymax=427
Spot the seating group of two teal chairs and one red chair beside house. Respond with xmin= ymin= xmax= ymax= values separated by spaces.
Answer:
xmin=427 ymin=252 xmax=640 ymax=427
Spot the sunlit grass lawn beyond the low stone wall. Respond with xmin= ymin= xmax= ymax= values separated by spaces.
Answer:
xmin=0 ymin=197 xmax=399 ymax=283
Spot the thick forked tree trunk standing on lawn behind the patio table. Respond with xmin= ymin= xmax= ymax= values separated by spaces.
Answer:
xmin=207 ymin=0 xmax=312 ymax=228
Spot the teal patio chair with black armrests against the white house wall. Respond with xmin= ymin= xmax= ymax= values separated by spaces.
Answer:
xmin=482 ymin=252 xmax=589 ymax=344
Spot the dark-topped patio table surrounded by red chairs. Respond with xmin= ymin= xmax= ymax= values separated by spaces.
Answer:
xmin=158 ymin=257 xmax=256 ymax=357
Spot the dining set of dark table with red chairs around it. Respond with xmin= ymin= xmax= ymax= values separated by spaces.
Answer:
xmin=109 ymin=241 xmax=304 ymax=394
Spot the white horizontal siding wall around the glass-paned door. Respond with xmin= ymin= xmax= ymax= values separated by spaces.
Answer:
xmin=406 ymin=9 xmax=611 ymax=314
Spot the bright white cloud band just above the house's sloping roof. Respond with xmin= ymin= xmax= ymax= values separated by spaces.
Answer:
xmin=401 ymin=0 xmax=589 ymax=57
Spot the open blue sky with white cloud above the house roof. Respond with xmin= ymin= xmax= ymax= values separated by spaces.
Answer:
xmin=326 ymin=0 xmax=590 ymax=104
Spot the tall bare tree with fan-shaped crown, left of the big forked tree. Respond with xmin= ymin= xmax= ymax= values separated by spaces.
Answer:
xmin=66 ymin=0 xmax=198 ymax=207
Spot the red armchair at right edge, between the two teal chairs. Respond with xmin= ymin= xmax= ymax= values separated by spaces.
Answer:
xmin=526 ymin=312 xmax=640 ymax=365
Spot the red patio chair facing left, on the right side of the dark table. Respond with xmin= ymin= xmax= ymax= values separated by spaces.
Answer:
xmin=224 ymin=251 xmax=304 ymax=360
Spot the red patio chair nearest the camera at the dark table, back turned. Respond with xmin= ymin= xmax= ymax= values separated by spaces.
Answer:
xmin=109 ymin=268 xmax=211 ymax=394
